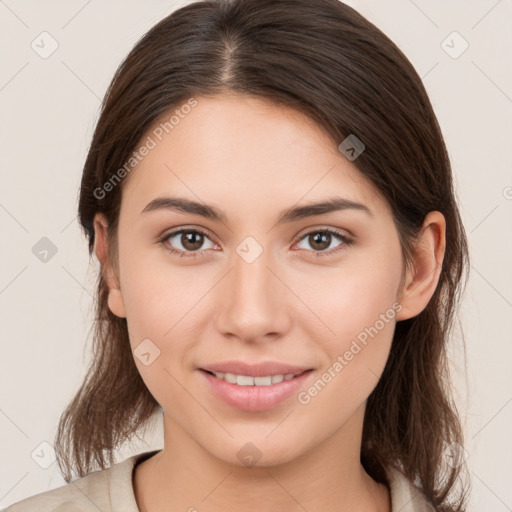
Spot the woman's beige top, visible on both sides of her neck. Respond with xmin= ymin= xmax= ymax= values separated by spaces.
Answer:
xmin=4 ymin=450 xmax=433 ymax=512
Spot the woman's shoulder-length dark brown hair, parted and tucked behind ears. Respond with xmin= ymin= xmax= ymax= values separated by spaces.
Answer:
xmin=55 ymin=0 xmax=468 ymax=511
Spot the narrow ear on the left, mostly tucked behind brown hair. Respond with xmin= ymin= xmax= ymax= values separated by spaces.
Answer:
xmin=94 ymin=213 xmax=126 ymax=318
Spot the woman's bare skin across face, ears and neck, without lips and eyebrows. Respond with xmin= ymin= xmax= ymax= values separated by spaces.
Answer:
xmin=95 ymin=94 xmax=445 ymax=512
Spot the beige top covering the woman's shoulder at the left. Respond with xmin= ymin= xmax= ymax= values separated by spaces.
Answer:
xmin=3 ymin=454 xmax=156 ymax=512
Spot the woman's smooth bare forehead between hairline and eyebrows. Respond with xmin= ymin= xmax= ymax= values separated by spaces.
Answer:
xmin=119 ymin=95 xmax=386 ymax=217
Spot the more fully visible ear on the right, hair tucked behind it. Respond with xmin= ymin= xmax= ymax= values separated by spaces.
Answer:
xmin=396 ymin=211 xmax=446 ymax=321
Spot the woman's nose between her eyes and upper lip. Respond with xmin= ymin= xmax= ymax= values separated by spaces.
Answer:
xmin=216 ymin=244 xmax=293 ymax=343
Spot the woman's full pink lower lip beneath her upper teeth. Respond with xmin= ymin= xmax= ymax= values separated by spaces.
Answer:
xmin=200 ymin=370 xmax=312 ymax=412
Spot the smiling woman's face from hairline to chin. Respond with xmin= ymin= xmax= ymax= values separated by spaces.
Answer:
xmin=102 ymin=95 xmax=410 ymax=465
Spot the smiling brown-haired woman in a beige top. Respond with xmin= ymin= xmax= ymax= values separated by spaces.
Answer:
xmin=7 ymin=0 xmax=468 ymax=512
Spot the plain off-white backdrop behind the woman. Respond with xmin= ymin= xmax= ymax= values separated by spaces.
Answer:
xmin=0 ymin=0 xmax=512 ymax=512
